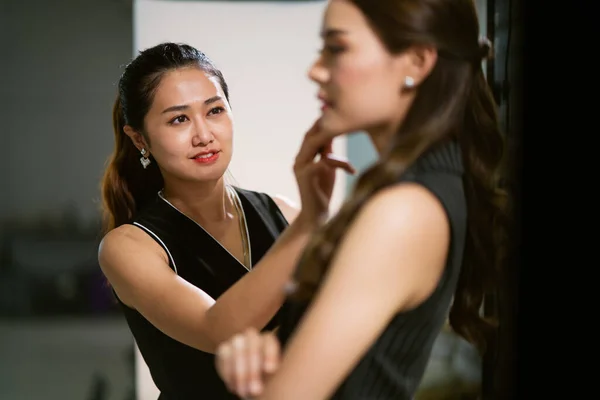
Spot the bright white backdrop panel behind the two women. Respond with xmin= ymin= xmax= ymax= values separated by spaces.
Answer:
xmin=134 ymin=0 xmax=346 ymax=400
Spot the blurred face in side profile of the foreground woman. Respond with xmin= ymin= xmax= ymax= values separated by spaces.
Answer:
xmin=309 ymin=0 xmax=409 ymax=138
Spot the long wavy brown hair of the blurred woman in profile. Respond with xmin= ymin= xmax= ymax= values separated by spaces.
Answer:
xmin=292 ymin=0 xmax=508 ymax=353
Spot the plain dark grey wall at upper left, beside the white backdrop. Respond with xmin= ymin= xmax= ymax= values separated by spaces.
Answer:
xmin=0 ymin=0 xmax=133 ymax=225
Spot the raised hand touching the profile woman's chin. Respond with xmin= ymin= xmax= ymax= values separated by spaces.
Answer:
xmin=294 ymin=120 xmax=356 ymax=225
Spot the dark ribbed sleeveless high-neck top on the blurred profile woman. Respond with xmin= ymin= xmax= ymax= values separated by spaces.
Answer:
xmin=278 ymin=142 xmax=467 ymax=400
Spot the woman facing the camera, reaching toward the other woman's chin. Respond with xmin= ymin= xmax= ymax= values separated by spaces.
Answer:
xmin=99 ymin=43 xmax=353 ymax=400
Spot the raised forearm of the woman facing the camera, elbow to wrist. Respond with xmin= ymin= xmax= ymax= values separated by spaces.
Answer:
xmin=205 ymin=219 xmax=314 ymax=345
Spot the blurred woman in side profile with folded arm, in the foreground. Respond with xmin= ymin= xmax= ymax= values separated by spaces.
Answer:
xmin=216 ymin=0 xmax=507 ymax=400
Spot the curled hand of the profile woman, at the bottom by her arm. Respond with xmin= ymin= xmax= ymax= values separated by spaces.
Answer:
xmin=215 ymin=328 xmax=280 ymax=398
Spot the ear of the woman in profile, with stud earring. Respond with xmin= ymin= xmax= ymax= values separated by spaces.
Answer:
xmin=397 ymin=46 xmax=438 ymax=87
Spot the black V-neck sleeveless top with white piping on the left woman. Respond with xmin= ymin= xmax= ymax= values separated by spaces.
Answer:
xmin=121 ymin=188 xmax=287 ymax=400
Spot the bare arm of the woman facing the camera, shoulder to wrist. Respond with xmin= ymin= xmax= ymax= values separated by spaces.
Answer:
xmin=98 ymin=202 xmax=313 ymax=352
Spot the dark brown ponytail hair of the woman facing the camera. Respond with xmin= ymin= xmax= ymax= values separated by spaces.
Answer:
xmin=101 ymin=43 xmax=229 ymax=238
